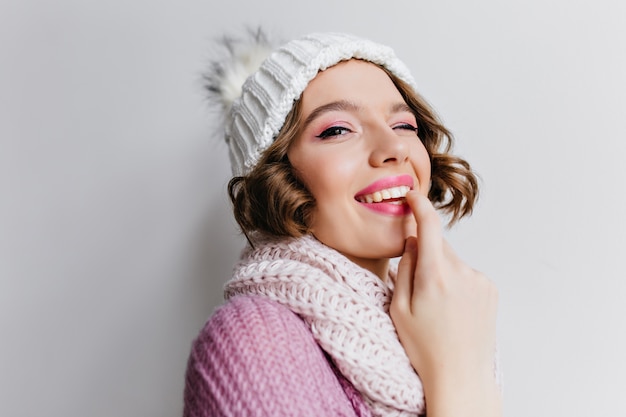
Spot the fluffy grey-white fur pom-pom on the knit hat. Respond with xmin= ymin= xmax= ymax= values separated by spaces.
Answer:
xmin=204 ymin=28 xmax=273 ymax=116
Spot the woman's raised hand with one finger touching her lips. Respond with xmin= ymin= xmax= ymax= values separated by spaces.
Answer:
xmin=390 ymin=192 xmax=500 ymax=417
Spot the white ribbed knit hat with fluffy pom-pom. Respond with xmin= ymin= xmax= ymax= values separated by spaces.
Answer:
xmin=207 ymin=33 xmax=415 ymax=175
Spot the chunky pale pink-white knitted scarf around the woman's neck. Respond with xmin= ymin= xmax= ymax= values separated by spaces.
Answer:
xmin=225 ymin=236 xmax=425 ymax=416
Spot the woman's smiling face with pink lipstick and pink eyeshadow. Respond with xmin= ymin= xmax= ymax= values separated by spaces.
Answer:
xmin=288 ymin=60 xmax=430 ymax=273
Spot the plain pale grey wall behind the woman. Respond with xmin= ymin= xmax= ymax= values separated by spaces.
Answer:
xmin=0 ymin=0 xmax=626 ymax=417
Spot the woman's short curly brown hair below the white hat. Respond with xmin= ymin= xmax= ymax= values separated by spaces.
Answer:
xmin=228 ymin=63 xmax=478 ymax=239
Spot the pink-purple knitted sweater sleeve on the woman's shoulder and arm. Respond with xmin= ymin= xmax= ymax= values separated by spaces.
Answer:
xmin=183 ymin=296 xmax=369 ymax=417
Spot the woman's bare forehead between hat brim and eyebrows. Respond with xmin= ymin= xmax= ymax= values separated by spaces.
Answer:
xmin=301 ymin=59 xmax=404 ymax=114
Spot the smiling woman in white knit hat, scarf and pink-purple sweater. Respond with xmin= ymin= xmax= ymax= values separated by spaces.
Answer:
xmin=184 ymin=34 xmax=501 ymax=417
